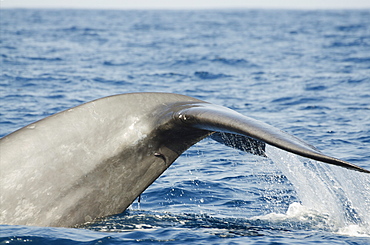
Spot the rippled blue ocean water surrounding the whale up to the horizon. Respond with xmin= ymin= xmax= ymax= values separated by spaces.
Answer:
xmin=0 ymin=9 xmax=370 ymax=244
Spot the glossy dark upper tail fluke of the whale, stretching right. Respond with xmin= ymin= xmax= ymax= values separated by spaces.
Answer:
xmin=174 ymin=104 xmax=370 ymax=173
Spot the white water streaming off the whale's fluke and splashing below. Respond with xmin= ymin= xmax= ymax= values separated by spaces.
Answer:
xmin=260 ymin=147 xmax=370 ymax=236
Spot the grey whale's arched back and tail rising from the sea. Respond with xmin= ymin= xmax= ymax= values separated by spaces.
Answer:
xmin=0 ymin=93 xmax=370 ymax=227
